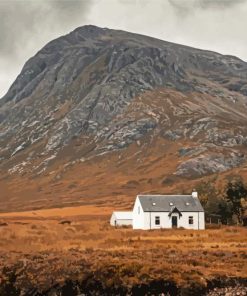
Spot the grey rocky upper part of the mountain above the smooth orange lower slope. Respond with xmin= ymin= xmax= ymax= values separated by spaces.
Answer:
xmin=0 ymin=26 xmax=247 ymax=210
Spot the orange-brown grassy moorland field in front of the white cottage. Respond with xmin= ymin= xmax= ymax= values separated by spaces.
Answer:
xmin=0 ymin=206 xmax=247 ymax=295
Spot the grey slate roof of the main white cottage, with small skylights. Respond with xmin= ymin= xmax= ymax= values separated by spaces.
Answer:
xmin=137 ymin=195 xmax=204 ymax=212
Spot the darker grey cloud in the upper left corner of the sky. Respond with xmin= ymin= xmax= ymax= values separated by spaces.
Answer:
xmin=0 ymin=0 xmax=92 ymax=57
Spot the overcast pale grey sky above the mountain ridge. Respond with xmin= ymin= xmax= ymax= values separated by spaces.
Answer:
xmin=0 ymin=0 xmax=247 ymax=97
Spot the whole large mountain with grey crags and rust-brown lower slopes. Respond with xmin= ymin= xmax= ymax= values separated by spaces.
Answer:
xmin=0 ymin=26 xmax=247 ymax=211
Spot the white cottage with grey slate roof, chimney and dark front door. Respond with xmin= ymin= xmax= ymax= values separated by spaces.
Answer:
xmin=133 ymin=192 xmax=205 ymax=229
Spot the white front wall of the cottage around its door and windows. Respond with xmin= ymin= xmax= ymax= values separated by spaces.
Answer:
xmin=137 ymin=212 xmax=205 ymax=229
